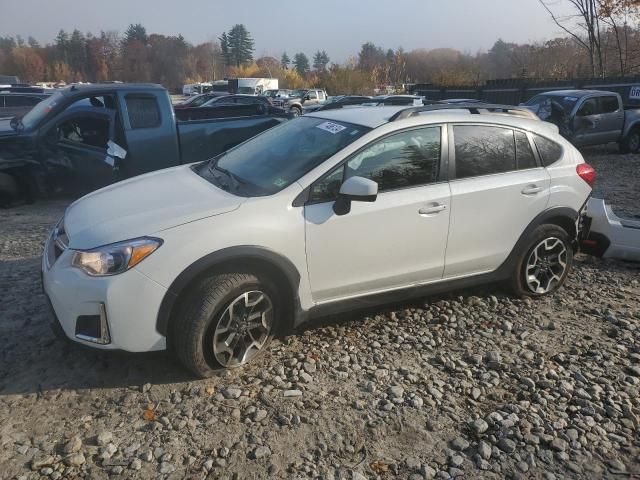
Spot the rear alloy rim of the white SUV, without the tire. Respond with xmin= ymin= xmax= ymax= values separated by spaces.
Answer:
xmin=525 ymin=237 xmax=567 ymax=295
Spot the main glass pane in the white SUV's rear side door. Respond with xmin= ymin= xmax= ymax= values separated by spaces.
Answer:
xmin=453 ymin=125 xmax=516 ymax=178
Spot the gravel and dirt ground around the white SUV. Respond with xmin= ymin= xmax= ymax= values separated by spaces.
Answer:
xmin=0 ymin=150 xmax=640 ymax=480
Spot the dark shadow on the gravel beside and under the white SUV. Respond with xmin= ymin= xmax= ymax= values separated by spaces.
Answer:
xmin=0 ymin=258 xmax=500 ymax=396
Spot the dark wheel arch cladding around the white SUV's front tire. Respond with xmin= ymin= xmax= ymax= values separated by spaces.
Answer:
xmin=156 ymin=245 xmax=300 ymax=336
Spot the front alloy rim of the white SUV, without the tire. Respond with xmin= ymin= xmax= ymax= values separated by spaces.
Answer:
xmin=213 ymin=290 xmax=273 ymax=367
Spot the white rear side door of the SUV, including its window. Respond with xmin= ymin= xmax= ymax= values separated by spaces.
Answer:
xmin=444 ymin=124 xmax=550 ymax=278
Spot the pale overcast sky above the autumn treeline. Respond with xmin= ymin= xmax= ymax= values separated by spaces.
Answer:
xmin=0 ymin=0 xmax=560 ymax=62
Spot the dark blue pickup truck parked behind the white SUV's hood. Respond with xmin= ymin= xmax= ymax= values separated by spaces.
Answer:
xmin=0 ymin=84 xmax=288 ymax=204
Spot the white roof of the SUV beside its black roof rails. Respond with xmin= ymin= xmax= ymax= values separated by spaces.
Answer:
xmin=304 ymin=105 xmax=558 ymax=133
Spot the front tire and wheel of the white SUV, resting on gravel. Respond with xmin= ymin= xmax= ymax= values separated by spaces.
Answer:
xmin=171 ymin=273 xmax=281 ymax=378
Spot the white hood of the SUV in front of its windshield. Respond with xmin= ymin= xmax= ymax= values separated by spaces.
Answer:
xmin=64 ymin=165 xmax=246 ymax=250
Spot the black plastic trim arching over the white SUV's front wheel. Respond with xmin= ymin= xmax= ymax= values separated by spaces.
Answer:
xmin=156 ymin=245 xmax=300 ymax=336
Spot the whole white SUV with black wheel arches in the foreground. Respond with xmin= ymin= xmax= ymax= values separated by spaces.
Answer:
xmin=42 ymin=105 xmax=594 ymax=376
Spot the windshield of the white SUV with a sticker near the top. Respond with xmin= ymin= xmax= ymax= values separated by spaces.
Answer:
xmin=196 ymin=117 xmax=371 ymax=196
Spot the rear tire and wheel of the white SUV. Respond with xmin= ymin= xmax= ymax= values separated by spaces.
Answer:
xmin=511 ymin=224 xmax=573 ymax=297
